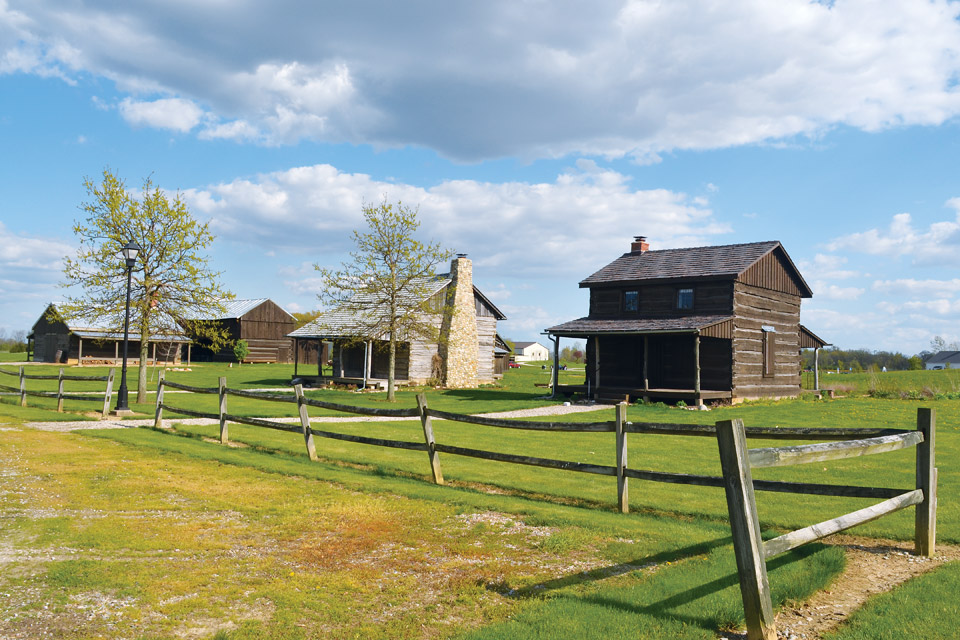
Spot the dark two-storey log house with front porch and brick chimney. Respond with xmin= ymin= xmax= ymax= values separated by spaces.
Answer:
xmin=546 ymin=236 xmax=824 ymax=404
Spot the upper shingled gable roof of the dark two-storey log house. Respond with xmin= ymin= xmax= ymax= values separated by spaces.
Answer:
xmin=580 ymin=240 xmax=813 ymax=298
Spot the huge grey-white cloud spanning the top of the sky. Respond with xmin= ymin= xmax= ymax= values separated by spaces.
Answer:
xmin=0 ymin=0 xmax=960 ymax=162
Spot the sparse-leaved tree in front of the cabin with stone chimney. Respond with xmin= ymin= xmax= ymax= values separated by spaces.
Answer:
xmin=314 ymin=199 xmax=453 ymax=402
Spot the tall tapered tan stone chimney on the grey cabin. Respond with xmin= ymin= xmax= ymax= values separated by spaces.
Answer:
xmin=440 ymin=253 xmax=479 ymax=389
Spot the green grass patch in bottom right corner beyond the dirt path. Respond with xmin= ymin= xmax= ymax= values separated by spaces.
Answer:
xmin=825 ymin=562 xmax=960 ymax=640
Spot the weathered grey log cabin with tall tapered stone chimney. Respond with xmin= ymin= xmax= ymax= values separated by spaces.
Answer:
xmin=289 ymin=257 xmax=507 ymax=386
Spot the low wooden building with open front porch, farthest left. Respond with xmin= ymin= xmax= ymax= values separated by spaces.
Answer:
xmin=27 ymin=304 xmax=190 ymax=365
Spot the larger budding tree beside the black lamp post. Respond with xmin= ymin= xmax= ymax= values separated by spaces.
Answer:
xmin=57 ymin=169 xmax=233 ymax=403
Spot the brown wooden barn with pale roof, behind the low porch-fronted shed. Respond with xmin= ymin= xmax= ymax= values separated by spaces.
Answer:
xmin=187 ymin=298 xmax=296 ymax=362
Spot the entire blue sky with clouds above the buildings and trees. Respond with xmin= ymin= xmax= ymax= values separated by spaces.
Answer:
xmin=0 ymin=0 xmax=960 ymax=354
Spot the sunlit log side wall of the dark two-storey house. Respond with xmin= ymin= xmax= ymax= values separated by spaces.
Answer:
xmin=733 ymin=283 xmax=800 ymax=398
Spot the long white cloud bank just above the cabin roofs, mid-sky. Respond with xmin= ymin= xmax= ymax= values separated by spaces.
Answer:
xmin=184 ymin=161 xmax=730 ymax=278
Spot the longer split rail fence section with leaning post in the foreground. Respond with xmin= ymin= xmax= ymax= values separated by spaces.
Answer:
xmin=154 ymin=371 xmax=937 ymax=640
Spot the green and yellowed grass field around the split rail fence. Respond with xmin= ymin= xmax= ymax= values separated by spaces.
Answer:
xmin=0 ymin=366 xmax=960 ymax=640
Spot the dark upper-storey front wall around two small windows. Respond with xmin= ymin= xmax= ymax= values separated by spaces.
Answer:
xmin=590 ymin=281 xmax=733 ymax=318
